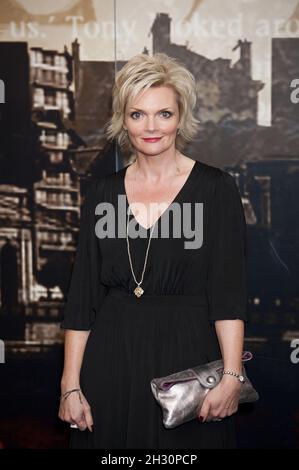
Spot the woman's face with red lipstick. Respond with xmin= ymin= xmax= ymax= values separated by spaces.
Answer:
xmin=124 ymin=86 xmax=179 ymax=155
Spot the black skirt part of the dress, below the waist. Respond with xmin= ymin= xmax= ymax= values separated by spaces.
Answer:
xmin=70 ymin=288 xmax=237 ymax=449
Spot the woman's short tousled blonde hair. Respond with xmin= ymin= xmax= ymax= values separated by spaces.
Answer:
xmin=106 ymin=53 xmax=200 ymax=151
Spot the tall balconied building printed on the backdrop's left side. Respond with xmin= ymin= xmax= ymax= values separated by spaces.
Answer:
xmin=0 ymin=43 xmax=80 ymax=339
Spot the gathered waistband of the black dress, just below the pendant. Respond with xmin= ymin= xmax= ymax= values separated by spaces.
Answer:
xmin=107 ymin=287 xmax=208 ymax=307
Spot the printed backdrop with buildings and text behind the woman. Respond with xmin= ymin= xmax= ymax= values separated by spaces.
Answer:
xmin=0 ymin=0 xmax=299 ymax=448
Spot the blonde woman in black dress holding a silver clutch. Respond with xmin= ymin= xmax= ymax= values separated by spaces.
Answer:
xmin=59 ymin=54 xmax=247 ymax=449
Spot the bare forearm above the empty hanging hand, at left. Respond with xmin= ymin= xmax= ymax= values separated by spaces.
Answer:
xmin=61 ymin=330 xmax=90 ymax=393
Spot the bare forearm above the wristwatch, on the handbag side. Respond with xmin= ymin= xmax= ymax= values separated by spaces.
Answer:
xmin=215 ymin=319 xmax=244 ymax=373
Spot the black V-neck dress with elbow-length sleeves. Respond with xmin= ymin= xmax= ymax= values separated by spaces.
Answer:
xmin=61 ymin=161 xmax=247 ymax=449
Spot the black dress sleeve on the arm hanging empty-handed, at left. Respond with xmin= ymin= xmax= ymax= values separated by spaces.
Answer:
xmin=60 ymin=181 xmax=105 ymax=330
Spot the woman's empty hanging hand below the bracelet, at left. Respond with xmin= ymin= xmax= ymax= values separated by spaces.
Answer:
xmin=58 ymin=391 xmax=93 ymax=432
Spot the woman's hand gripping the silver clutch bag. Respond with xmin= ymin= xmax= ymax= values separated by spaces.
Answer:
xmin=198 ymin=375 xmax=243 ymax=422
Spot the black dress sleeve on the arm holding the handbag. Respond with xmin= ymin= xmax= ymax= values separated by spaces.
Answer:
xmin=207 ymin=170 xmax=248 ymax=323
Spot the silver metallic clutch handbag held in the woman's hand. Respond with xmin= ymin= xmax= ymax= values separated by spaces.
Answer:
xmin=150 ymin=351 xmax=259 ymax=429
